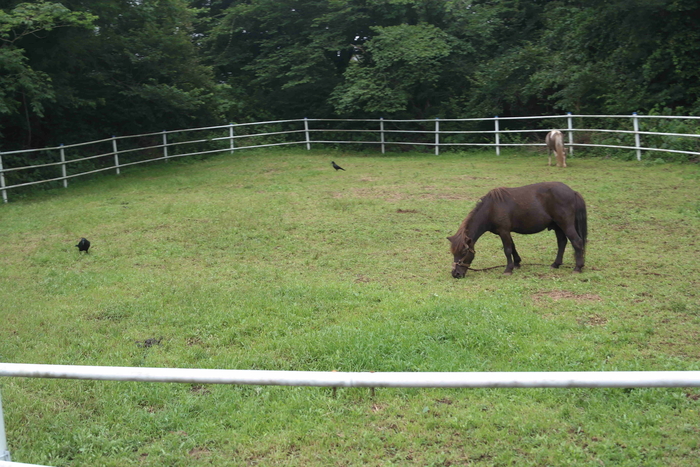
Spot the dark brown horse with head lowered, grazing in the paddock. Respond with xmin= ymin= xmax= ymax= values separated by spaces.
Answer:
xmin=447 ymin=182 xmax=588 ymax=279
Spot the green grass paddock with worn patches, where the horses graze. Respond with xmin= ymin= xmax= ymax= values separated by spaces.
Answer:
xmin=0 ymin=149 xmax=700 ymax=467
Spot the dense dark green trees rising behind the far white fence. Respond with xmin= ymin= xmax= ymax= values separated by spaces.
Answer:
xmin=0 ymin=0 xmax=700 ymax=151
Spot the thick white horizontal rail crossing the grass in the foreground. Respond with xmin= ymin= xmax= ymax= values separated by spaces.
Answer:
xmin=0 ymin=363 xmax=700 ymax=388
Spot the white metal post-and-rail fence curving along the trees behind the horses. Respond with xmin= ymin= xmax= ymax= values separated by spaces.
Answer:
xmin=0 ymin=113 xmax=700 ymax=202
